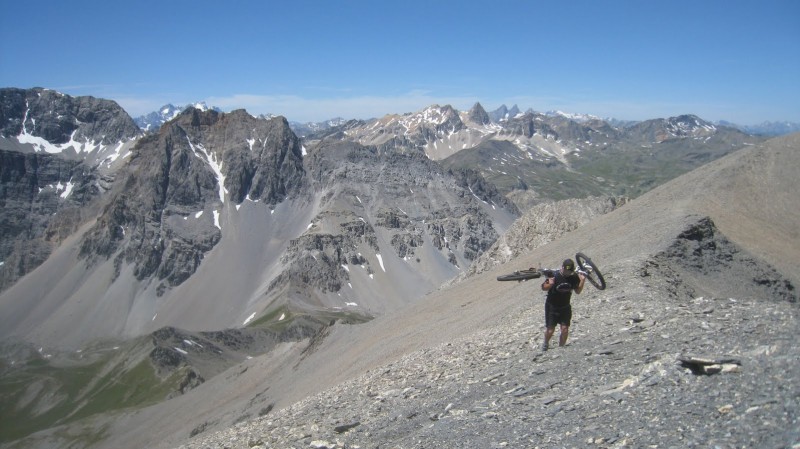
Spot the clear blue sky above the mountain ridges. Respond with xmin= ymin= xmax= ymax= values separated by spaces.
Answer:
xmin=0 ymin=0 xmax=800 ymax=125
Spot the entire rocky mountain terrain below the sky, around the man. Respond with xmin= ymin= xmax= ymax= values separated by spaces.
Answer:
xmin=0 ymin=88 xmax=800 ymax=448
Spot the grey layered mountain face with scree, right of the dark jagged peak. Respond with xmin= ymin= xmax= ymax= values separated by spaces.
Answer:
xmin=269 ymin=140 xmax=516 ymax=312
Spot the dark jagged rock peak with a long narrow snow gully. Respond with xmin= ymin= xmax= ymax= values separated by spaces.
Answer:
xmin=81 ymin=109 xmax=304 ymax=292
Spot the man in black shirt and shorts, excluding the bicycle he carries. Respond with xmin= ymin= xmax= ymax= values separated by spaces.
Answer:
xmin=542 ymin=259 xmax=586 ymax=351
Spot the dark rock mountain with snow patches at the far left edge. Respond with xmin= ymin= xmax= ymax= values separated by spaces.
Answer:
xmin=0 ymin=88 xmax=139 ymax=291
